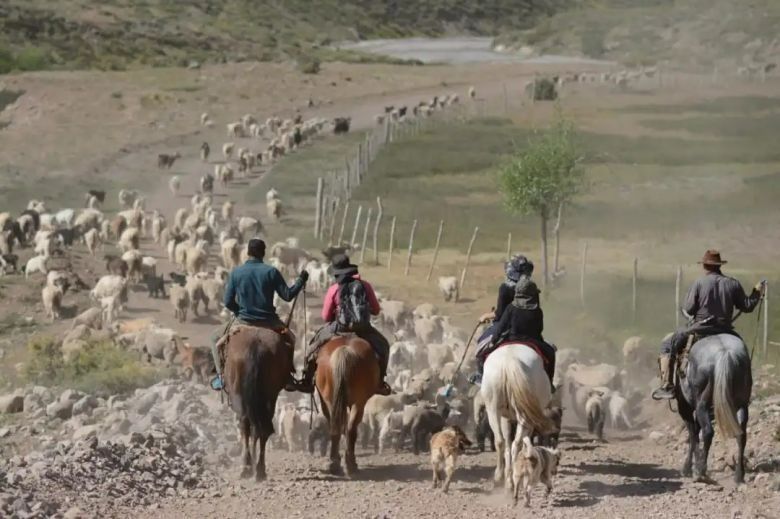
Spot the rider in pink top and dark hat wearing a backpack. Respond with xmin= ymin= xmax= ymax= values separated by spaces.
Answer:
xmin=298 ymin=254 xmax=391 ymax=395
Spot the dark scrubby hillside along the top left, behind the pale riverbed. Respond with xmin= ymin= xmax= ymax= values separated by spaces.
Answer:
xmin=0 ymin=0 xmax=554 ymax=73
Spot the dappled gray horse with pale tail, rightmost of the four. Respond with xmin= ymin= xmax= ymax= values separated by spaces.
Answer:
xmin=677 ymin=334 xmax=753 ymax=483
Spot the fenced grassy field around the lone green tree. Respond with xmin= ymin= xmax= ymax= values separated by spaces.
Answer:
xmin=254 ymin=87 xmax=780 ymax=364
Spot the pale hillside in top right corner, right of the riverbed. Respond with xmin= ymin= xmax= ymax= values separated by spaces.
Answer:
xmin=496 ymin=0 xmax=780 ymax=70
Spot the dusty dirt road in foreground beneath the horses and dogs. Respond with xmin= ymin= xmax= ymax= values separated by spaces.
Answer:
xmin=134 ymin=420 xmax=780 ymax=519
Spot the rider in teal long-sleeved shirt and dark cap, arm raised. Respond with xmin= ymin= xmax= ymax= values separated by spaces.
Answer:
xmin=212 ymin=242 xmax=309 ymax=391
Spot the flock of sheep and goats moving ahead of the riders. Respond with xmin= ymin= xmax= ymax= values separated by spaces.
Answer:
xmin=0 ymin=82 xmax=652 ymax=504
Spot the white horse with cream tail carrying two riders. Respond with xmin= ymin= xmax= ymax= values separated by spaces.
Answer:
xmin=480 ymin=344 xmax=555 ymax=491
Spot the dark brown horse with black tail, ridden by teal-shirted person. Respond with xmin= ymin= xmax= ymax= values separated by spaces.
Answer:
xmin=225 ymin=326 xmax=292 ymax=481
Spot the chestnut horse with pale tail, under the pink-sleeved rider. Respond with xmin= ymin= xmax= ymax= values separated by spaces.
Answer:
xmin=315 ymin=336 xmax=379 ymax=476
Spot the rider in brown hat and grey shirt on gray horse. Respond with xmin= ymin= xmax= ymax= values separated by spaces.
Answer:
xmin=653 ymin=250 xmax=765 ymax=400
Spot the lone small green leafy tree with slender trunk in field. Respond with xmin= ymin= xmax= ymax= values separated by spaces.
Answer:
xmin=499 ymin=115 xmax=584 ymax=283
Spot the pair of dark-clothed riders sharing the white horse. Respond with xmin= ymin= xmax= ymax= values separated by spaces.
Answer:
xmin=470 ymin=256 xmax=555 ymax=383
